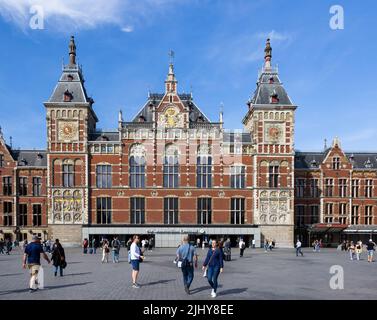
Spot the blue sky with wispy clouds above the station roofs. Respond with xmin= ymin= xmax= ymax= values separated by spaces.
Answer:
xmin=0 ymin=0 xmax=377 ymax=151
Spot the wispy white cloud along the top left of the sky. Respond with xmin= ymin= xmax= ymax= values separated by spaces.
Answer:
xmin=0 ymin=0 xmax=184 ymax=32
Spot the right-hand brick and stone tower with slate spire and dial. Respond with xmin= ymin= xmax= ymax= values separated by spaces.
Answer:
xmin=243 ymin=39 xmax=296 ymax=247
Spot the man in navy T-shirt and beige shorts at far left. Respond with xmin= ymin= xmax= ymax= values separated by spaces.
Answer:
xmin=22 ymin=235 xmax=50 ymax=292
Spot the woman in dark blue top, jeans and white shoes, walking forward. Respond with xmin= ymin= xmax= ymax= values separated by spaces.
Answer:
xmin=203 ymin=240 xmax=224 ymax=298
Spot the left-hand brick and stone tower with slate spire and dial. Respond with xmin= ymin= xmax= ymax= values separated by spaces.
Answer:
xmin=44 ymin=36 xmax=98 ymax=243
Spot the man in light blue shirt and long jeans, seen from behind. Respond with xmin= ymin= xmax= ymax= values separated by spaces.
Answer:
xmin=177 ymin=236 xmax=198 ymax=294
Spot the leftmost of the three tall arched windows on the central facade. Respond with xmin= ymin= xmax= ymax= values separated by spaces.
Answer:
xmin=130 ymin=144 xmax=145 ymax=189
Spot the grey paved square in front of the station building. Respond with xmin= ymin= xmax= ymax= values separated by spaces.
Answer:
xmin=0 ymin=248 xmax=377 ymax=300
